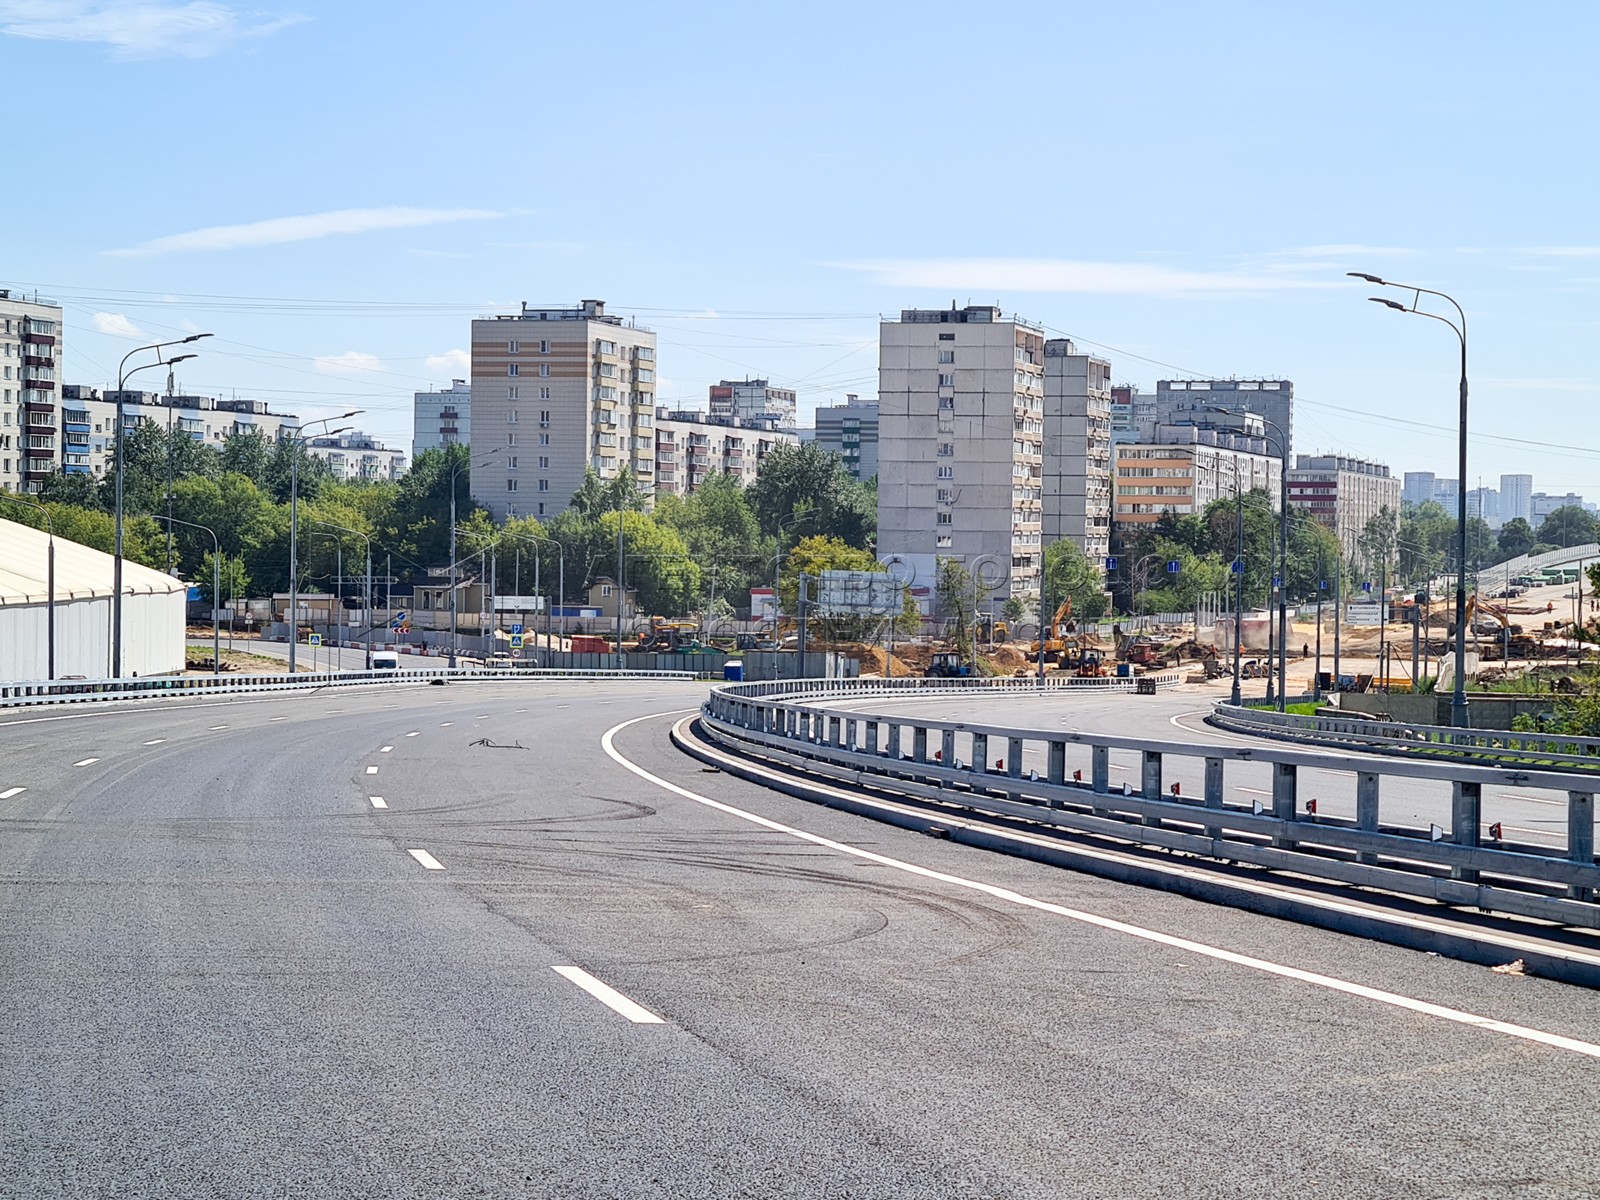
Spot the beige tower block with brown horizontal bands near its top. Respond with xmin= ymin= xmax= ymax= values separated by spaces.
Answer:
xmin=470 ymin=299 xmax=656 ymax=520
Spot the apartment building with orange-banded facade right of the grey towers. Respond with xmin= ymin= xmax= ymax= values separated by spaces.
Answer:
xmin=1115 ymin=413 xmax=1283 ymax=533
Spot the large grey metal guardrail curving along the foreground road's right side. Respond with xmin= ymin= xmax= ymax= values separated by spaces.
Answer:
xmin=702 ymin=680 xmax=1600 ymax=930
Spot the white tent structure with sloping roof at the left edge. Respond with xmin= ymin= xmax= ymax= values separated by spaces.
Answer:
xmin=0 ymin=520 xmax=187 ymax=680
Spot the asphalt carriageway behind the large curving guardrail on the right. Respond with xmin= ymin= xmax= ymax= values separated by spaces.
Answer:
xmin=812 ymin=690 xmax=1587 ymax=850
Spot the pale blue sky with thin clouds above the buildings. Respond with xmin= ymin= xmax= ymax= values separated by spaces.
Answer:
xmin=9 ymin=0 xmax=1600 ymax=499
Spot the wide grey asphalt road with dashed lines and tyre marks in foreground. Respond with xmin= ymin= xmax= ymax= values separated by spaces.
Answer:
xmin=0 ymin=680 xmax=1600 ymax=1200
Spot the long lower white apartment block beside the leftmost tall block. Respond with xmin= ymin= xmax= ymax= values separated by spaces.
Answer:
xmin=61 ymin=384 xmax=299 ymax=477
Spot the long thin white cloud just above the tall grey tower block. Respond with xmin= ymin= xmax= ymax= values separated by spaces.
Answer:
xmin=832 ymin=258 xmax=1339 ymax=296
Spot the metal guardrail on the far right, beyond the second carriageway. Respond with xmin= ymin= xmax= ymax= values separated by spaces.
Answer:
xmin=1211 ymin=702 xmax=1600 ymax=773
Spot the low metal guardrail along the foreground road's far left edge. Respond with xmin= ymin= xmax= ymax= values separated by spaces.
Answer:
xmin=0 ymin=667 xmax=698 ymax=709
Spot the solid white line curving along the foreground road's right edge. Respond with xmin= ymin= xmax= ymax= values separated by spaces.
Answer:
xmin=600 ymin=710 xmax=1600 ymax=1058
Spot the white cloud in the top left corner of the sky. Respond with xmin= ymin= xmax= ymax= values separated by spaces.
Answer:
xmin=0 ymin=0 xmax=307 ymax=58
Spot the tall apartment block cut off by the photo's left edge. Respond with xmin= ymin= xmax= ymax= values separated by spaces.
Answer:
xmin=0 ymin=288 xmax=62 ymax=491
